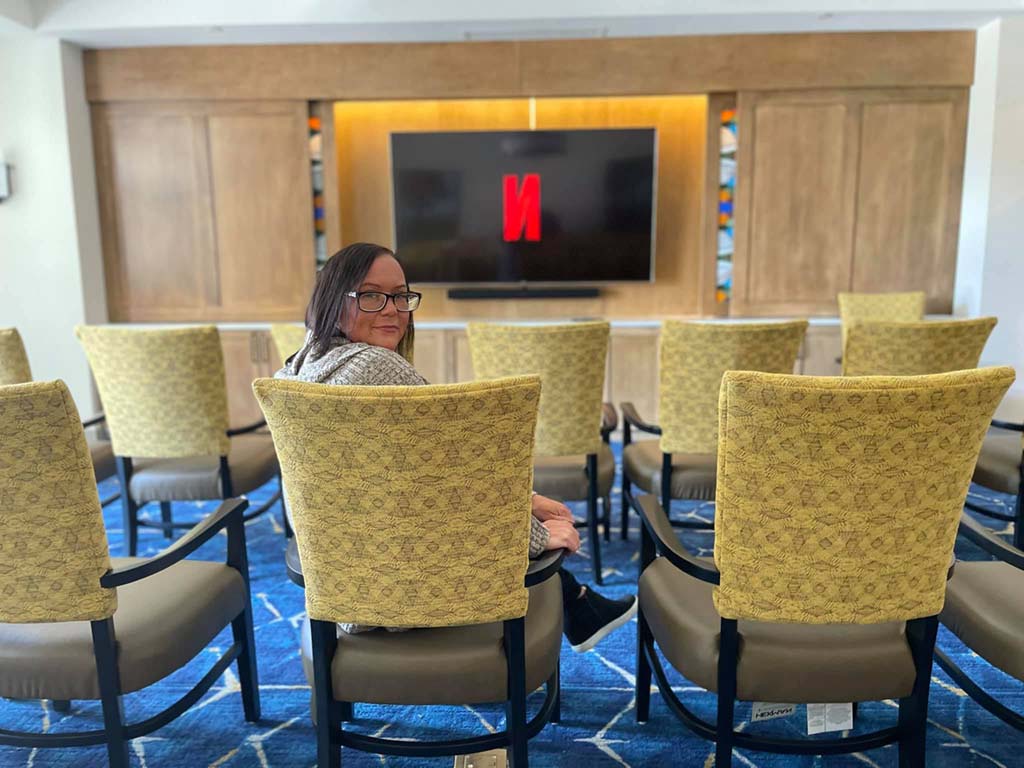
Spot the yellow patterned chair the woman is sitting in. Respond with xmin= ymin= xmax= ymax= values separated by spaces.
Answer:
xmin=253 ymin=376 xmax=562 ymax=768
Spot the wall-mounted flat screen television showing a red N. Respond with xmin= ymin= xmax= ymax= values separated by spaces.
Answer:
xmin=391 ymin=128 xmax=656 ymax=285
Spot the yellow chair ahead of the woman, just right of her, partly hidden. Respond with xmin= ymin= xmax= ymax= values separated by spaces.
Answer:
xmin=466 ymin=323 xmax=615 ymax=584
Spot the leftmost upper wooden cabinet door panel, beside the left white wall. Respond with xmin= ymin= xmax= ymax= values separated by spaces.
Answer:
xmin=92 ymin=105 xmax=218 ymax=322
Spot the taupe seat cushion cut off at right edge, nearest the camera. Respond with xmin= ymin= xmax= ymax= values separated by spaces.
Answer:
xmin=939 ymin=562 xmax=1024 ymax=680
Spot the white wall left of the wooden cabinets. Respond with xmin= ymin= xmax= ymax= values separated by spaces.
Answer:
xmin=0 ymin=38 xmax=106 ymax=414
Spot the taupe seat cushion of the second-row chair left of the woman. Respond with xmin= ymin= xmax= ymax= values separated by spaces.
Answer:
xmin=130 ymin=433 xmax=279 ymax=504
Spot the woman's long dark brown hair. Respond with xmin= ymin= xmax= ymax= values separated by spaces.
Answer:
xmin=306 ymin=243 xmax=415 ymax=364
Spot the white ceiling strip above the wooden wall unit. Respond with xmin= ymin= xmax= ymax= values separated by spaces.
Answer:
xmin=0 ymin=0 xmax=1024 ymax=48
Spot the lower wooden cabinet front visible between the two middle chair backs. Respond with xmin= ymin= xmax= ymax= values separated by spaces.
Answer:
xmin=608 ymin=328 xmax=660 ymax=423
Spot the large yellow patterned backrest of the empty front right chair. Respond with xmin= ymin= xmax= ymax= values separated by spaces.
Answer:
xmin=715 ymin=368 xmax=1014 ymax=624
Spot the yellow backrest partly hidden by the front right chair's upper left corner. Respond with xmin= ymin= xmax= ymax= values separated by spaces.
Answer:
xmin=657 ymin=321 xmax=807 ymax=454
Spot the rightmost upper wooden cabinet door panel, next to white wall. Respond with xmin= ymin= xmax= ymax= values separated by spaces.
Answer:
xmin=852 ymin=89 xmax=968 ymax=313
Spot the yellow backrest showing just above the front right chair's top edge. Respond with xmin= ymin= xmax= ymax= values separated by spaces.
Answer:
xmin=843 ymin=317 xmax=996 ymax=376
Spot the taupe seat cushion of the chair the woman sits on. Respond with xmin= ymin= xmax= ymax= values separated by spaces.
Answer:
xmin=302 ymin=575 xmax=562 ymax=705
